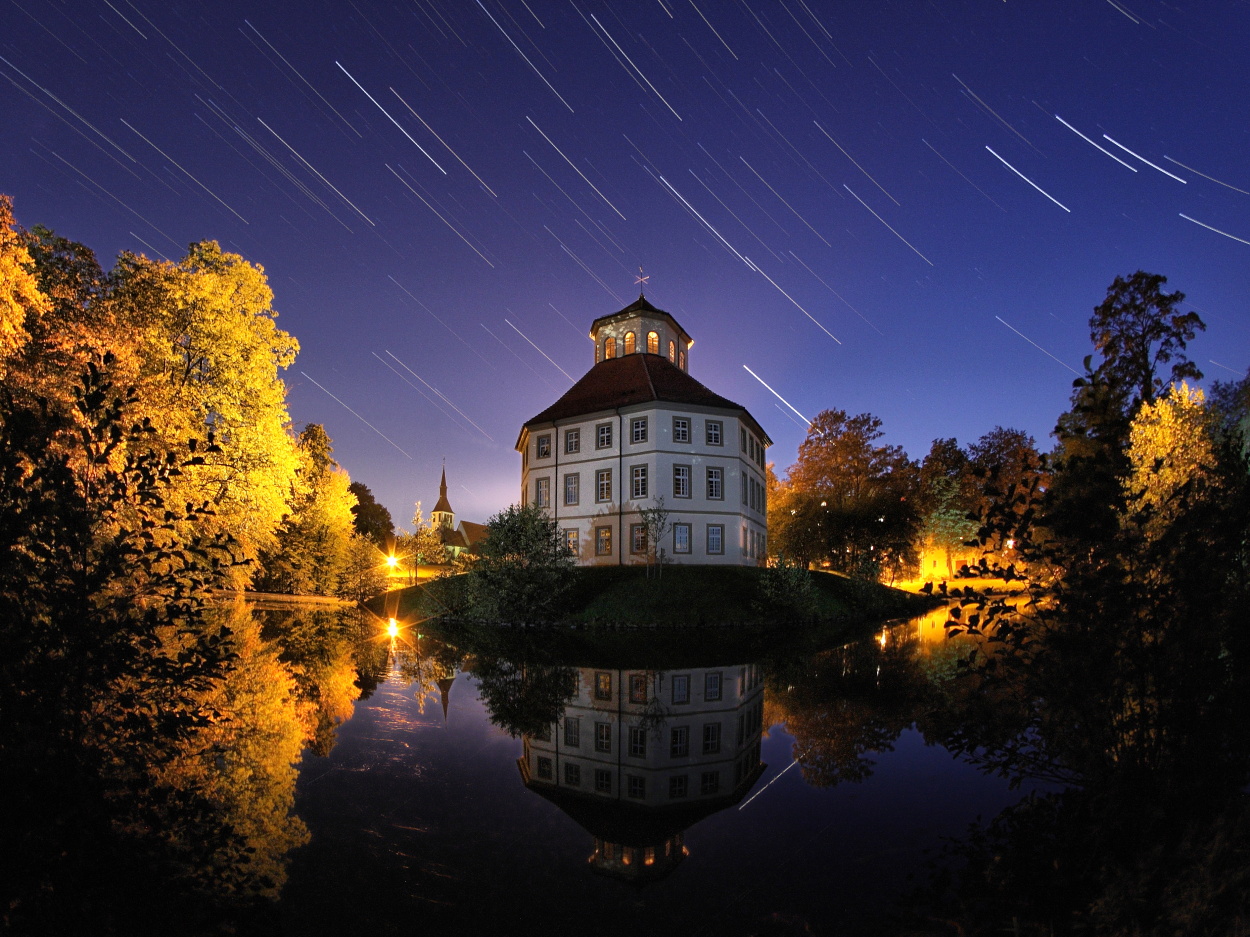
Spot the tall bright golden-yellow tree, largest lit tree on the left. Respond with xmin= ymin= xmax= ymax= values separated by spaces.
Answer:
xmin=108 ymin=241 xmax=299 ymax=556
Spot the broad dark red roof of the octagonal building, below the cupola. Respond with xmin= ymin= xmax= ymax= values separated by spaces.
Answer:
xmin=523 ymin=355 xmax=771 ymax=442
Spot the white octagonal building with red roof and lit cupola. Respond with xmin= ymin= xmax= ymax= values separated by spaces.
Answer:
xmin=516 ymin=296 xmax=773 ymax=566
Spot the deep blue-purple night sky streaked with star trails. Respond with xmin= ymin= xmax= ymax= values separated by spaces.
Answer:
xmin=0 ymin=0 xmax=1250 ymax=525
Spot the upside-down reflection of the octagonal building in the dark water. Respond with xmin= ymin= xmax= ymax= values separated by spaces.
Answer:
xmin=516 ymin=665 xmax=766 ymax=882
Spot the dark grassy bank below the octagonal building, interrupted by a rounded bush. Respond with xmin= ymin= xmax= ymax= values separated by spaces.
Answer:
xmin=370 ymin=566 xmax=930 ymax=630
